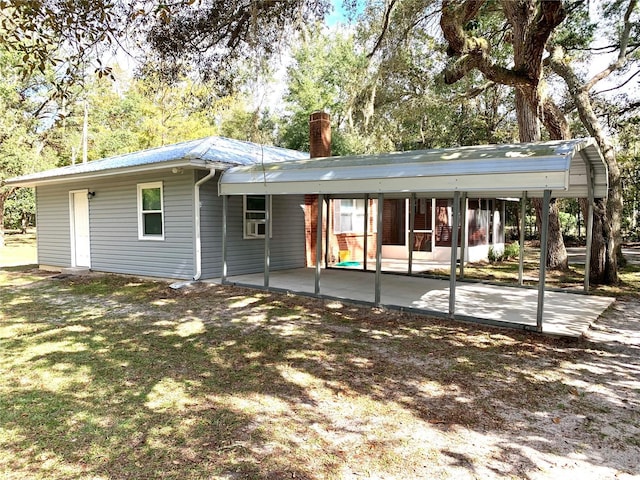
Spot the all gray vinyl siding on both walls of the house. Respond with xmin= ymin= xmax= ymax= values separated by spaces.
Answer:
xmin=36 ymin=170 xmax=305 ymax=279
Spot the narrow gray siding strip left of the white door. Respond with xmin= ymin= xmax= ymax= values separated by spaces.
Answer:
xmin=36 ymin=187 xmax=73 ymax=267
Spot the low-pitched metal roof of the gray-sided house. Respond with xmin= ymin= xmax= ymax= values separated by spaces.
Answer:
xmin=6 ymin=136 xmax=309 ymax=186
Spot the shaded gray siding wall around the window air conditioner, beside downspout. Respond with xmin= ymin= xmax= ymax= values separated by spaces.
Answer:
xmin=201 ymin=178 xmax=305 ymax=278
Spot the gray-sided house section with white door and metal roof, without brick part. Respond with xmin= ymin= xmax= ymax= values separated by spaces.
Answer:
xmin=7 ymin=137 xmax=308 ymax=279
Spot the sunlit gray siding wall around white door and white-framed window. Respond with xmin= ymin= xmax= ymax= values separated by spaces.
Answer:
xmin=37 ymin=170 xmax=195 ymax=279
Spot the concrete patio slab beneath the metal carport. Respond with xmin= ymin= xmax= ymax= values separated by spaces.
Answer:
xmin=221 ymin=268 xmax=615 ymax=337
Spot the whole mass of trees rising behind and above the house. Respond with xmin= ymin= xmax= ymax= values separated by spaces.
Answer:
xmin=0 ymin=0 xmax=640 ymax=282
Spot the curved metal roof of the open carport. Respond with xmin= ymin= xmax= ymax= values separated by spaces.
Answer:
xmin=219 ymin=138 xmax=608 ymax=198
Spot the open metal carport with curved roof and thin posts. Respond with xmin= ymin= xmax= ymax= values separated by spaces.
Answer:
xmin=219 ymin=138 xmax=608 ymax=332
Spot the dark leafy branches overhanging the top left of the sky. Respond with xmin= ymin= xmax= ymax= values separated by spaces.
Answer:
xmin=0 ymin=0 xmax=330 ymax=97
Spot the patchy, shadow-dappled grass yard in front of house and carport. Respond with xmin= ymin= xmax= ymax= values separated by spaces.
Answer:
xmin=0 ymin=269 xmax=640 ymax=479
